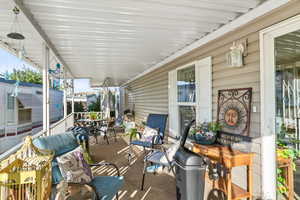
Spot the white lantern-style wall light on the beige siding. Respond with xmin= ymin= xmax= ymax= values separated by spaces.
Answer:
xmin=226 ymin=40 xmax=247 ymax=67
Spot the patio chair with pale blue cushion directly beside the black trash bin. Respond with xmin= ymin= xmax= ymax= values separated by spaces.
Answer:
xmin=141 ymin=141 xmax=180 ymax=190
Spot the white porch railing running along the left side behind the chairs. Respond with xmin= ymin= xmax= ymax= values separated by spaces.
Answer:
xmin=0 ymin=113 xmax=74 ymax=161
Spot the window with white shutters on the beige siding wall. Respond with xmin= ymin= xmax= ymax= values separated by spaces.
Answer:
xmin=169 ymin=57 xmax=212 ymax=138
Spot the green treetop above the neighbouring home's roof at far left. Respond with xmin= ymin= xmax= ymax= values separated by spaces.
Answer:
xmin=6 ymin=67 xmax=43 ymax=84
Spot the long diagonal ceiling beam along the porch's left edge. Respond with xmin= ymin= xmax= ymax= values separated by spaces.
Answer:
xmin=13 ymin=0 xmax=74 ymax=78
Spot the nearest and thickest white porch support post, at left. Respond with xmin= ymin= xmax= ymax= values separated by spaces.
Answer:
xmin=43 ymin=44 xmax=50 ymax=135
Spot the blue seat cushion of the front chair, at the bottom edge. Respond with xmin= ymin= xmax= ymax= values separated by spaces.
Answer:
xmin=90 ymin=176 xmax=124 ymax=200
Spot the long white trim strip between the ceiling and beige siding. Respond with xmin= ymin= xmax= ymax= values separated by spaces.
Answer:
xmin=122 ymin=0 xmax=290 ymax=86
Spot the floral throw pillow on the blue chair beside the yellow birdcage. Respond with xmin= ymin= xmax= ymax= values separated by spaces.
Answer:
xmin=56 ymin=147 xmax=93 ymax=183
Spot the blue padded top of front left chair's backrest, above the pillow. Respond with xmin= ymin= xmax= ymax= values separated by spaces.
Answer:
xmin=33 ymin=132 xmax=78 ymax=157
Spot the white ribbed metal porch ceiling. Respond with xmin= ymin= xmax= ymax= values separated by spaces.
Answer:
xmin=0 ymin=0 xmax=263 ymax=84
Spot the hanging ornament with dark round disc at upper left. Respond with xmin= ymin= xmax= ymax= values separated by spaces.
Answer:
xmin=6 ymin=7 xmax=25 ymax=59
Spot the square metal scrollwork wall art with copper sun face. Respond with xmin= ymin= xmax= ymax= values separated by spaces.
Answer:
xmin=217 ymin=88 xmax=252 ymax=136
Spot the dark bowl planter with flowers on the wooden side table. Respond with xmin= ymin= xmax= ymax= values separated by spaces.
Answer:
xmin=190 ymin=122 xmax=222 ymax=145
